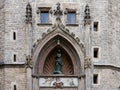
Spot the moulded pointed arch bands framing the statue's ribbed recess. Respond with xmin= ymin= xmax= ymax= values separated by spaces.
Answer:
xmin=33 ymin=29 xmax=84 ymax=75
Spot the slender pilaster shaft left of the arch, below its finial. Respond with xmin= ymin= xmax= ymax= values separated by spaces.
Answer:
xmin=26 ymin=24 xmax=32 ymax=90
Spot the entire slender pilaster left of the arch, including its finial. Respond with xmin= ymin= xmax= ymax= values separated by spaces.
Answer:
xmin=26 ymin=3 xmax=32 ymax=90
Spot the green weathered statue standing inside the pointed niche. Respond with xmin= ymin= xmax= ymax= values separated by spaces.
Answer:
xmin=53 ymin=49 xmax=62 ymax=74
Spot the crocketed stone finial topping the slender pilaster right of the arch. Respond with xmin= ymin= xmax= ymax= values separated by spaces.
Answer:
xmin=84 ymin=4 xmax=91 ymax=25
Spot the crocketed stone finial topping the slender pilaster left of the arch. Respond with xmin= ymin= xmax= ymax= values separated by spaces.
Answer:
xmin=26 ymin=3 xmax=32 ymax=24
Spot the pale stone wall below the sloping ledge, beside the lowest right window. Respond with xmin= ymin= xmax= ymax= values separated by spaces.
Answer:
xmin=92 ymin=67 xmax=120 ymax=90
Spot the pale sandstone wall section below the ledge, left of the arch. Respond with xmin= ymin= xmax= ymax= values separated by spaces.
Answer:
xmin=4 ymin=67 xmax=26 ymax=90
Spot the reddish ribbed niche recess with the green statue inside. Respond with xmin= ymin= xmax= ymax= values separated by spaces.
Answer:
xmin=43 ymin=47 xmax=74 ymax=75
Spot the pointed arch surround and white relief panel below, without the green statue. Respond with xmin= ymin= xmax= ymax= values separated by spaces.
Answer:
xmin=33 ymin=30 xmax=84 ymax=90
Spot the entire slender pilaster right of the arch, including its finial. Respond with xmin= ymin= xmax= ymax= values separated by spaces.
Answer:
xmin=84 ymin=4 xmax=92 ymax=90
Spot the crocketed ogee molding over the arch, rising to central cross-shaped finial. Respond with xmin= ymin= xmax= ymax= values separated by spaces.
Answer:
xmin=33 ymin=3 xmax=85 ymax=57
